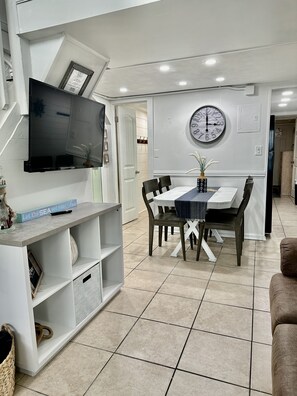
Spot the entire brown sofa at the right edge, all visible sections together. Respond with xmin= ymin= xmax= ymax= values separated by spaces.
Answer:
xmin=269 ymin=238 xmax=297 ymax=396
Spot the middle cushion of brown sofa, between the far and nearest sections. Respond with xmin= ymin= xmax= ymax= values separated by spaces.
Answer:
xmin=269 ymin=273 xmax=297 ymax=334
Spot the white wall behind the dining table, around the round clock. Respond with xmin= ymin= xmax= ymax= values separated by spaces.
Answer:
xmin=153 ymin=86 xmax=270 ymax=239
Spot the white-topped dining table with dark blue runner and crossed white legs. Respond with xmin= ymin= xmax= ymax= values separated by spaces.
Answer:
xmin=154 ymin=186 xmax=237 ymax=262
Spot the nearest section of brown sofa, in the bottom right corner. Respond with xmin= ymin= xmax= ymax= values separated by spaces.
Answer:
xmin=271 ymin=324 xmax=297 ymax=396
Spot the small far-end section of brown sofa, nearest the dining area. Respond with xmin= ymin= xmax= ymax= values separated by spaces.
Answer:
xmin=280 ymin=238 xmax=297 ymax=277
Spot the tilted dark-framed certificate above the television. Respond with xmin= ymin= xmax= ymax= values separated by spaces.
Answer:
xmin=59 ymin=61 xmax=94 ymax=95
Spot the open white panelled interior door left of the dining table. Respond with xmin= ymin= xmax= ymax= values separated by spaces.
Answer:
xmin=116 ymin=106 xmax=138 ymax=224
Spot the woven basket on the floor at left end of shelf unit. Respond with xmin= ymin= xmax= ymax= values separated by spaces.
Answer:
xmin=0 ymin=324 xmax=15 ymax=396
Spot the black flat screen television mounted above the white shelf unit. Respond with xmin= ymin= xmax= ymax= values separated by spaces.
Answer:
xmin=24 ymin=78 xmax=105 ymax=172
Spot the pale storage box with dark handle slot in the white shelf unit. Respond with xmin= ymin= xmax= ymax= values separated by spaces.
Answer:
xmin=73 ymin=264 xmax=102 ymax=324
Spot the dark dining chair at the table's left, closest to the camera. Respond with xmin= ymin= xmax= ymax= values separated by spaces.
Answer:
xmin=142 ymin=179 xmax=186 ymax=261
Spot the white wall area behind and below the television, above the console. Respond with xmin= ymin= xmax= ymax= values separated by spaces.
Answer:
xmin=0 ymin=113 xmax=92 ymax=212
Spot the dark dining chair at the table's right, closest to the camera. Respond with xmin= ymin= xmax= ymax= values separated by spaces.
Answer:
xmin=196 ymin=179 xmax=254 ymax=266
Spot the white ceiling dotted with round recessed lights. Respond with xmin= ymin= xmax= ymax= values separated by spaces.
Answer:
xmin=22 ymin=0 xmax=297 ymax=114
